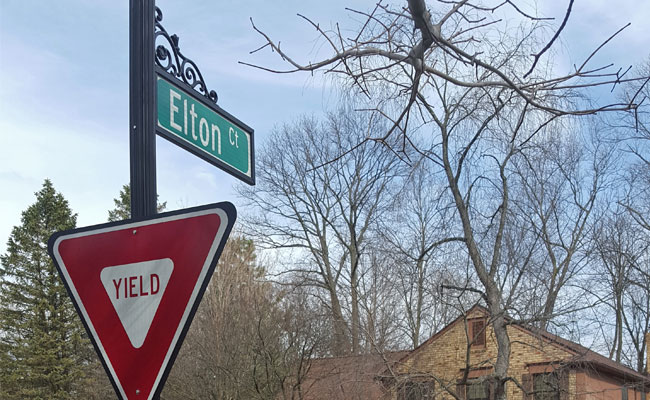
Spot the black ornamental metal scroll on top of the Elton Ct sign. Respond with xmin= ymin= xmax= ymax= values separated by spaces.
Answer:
xmin=154 ymin=7 xmax=218 ymax=103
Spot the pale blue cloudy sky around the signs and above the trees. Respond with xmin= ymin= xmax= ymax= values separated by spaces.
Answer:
xmin=0 ymin=0 xmax=650 ymax=254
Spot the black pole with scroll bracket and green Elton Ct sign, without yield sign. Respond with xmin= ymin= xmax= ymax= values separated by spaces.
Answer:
xmin=129 ymin=0 xmax=255 ymax=219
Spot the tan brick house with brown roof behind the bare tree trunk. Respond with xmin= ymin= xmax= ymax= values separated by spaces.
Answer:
xmin=296 ymin=306 xmax=650 ymax=400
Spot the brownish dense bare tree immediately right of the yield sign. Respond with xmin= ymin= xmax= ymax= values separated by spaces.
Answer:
xmin=162 ymin=237 xmax=320 ymax=400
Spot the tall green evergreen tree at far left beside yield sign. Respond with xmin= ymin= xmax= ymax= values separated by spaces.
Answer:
xmin=0 ymin=180 xmax=89 ymax=399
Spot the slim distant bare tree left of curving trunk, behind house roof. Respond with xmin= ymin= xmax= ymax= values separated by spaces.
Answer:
xmin=381 ymin=160 xmax=464 ymax=348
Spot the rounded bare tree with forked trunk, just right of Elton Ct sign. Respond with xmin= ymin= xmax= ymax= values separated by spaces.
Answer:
xmin=240 ymin=110 xmax=400 ymax=355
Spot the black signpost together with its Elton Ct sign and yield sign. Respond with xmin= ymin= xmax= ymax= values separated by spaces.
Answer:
xmin=48 ymin=0 xmax=255 ymax=400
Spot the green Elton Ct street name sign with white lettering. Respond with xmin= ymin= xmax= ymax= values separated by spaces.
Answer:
xmin=156 ymin=73 xmax=255 ymax=185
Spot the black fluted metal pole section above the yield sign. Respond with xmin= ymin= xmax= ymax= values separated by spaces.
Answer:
xmin=129 ymin=0 xmax=157 ymax=219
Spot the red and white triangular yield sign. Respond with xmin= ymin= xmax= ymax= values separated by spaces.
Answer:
xmin=49 ymin=203 xmax=237 ymax=400
